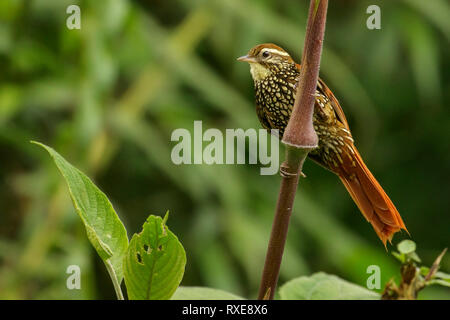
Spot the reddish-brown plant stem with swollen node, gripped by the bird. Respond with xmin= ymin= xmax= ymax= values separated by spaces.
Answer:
xmin=258 ymin=0 xmax=328 ymax=299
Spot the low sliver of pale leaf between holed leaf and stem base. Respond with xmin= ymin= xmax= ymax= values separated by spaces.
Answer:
xmin=171 ymin=287 xmax=244 ymax=300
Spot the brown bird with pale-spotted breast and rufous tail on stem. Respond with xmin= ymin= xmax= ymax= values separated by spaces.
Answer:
xmin=237 ymin=43 xmax=409 ymax=247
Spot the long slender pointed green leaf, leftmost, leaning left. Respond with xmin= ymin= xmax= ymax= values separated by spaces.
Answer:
xmin=32 ymin=141 xmax=128 ymax=299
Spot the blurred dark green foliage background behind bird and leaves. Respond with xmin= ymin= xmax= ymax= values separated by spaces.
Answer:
xmin=0 ymin=0 xmax=450 ymax=299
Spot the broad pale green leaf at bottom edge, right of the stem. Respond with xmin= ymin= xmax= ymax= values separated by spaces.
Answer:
xmin=280 ymin=272 xmax=380 ymax=300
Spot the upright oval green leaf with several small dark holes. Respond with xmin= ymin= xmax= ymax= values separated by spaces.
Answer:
xmin=124 ymin=214 xmax=186 ymax=300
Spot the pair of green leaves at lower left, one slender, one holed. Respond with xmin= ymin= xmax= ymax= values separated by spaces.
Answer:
xmin=33 ymin=142 xmax=186 ymax=300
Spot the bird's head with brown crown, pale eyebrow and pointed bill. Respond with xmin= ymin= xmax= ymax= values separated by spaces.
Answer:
xmin=237 ymin=43 xmax=295 ymax=82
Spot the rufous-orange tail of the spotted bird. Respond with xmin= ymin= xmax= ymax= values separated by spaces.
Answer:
xmin=338 ymin=146 xmax=409 ymax=247
